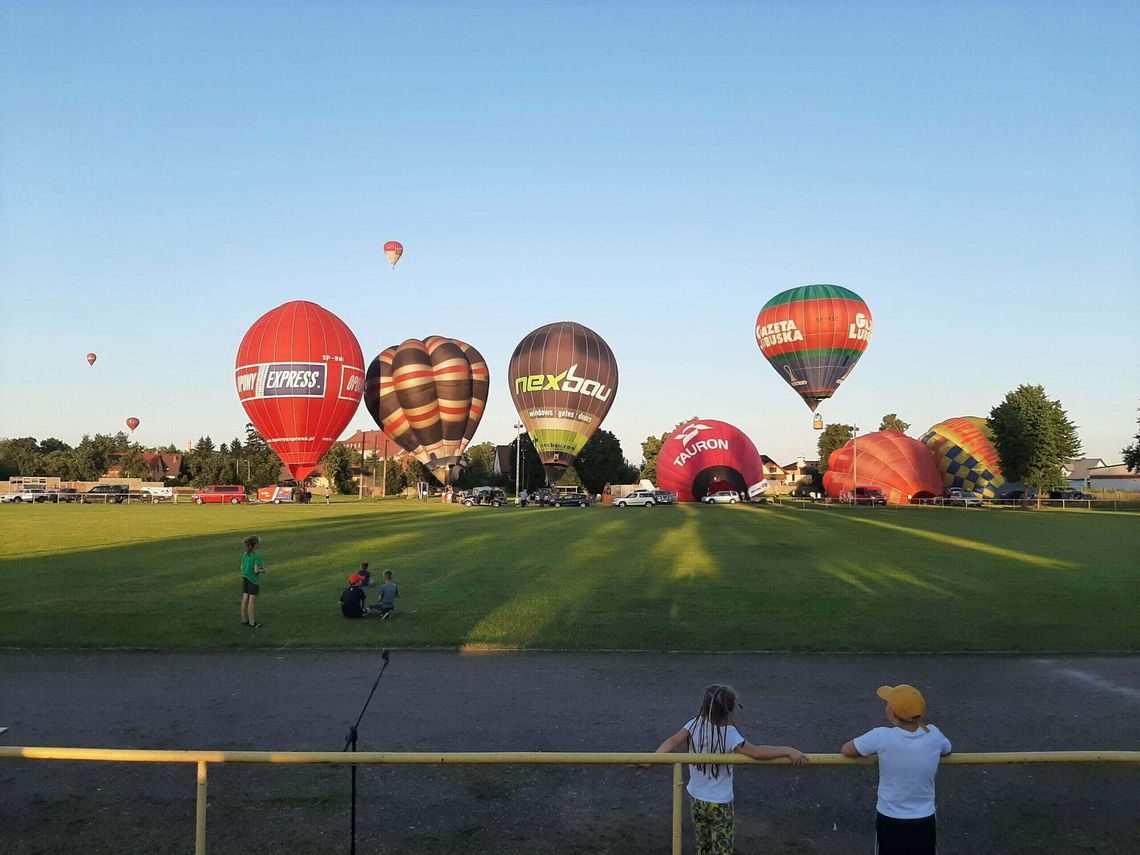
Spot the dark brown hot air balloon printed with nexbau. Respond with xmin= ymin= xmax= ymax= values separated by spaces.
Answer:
xmin=507 ymin=320 xmax=618 ymax=483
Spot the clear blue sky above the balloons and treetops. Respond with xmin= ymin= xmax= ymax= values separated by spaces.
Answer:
xmin=0 ymin=0 xmax=1140 ymax=463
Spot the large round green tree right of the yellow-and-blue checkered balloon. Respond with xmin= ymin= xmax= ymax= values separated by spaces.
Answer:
xmin=990 ymin=384 xmax=1081 ymax=494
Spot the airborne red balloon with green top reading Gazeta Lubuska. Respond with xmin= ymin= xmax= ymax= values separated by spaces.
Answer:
xmin=756 ymin=285 xmax=871 ymax=413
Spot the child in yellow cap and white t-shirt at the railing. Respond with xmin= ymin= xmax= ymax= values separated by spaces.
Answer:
xmin=842 ymin=685 xmax=952 ymax=855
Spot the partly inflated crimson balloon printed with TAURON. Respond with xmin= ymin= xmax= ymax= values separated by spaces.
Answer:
xmin=657 ymin=418 xmax=764 ymax=502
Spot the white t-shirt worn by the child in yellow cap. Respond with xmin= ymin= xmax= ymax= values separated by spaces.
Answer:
xmin=853 ymin=724 xmax=951 ymax=820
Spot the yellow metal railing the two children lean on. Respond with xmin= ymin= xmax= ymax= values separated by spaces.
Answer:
xmin=0 ymin=747 xmax=1140 ymax=855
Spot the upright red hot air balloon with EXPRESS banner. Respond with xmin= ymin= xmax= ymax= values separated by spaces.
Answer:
xmin=234 ymin=300 xmax=364 ymax=481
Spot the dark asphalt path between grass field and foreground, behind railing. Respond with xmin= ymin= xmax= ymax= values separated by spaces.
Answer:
xmin=0 ymin=650 xmax=1140 ymax=855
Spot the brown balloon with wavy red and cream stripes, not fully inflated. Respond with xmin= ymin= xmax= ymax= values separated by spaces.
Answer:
xmin=364 ymin=335 xmax=490 ymax=485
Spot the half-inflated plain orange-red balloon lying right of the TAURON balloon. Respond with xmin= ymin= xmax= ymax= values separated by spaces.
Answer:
xmin=823 ymin=431 xmax=942 ymax=505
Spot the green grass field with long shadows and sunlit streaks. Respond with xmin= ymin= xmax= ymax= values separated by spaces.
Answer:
xmin=0 ymin=500 xmax=1140 ymax=651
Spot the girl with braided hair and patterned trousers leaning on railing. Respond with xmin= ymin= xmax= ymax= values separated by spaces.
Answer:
xmin=638 ymin=684 xmax=807 ymax=855
